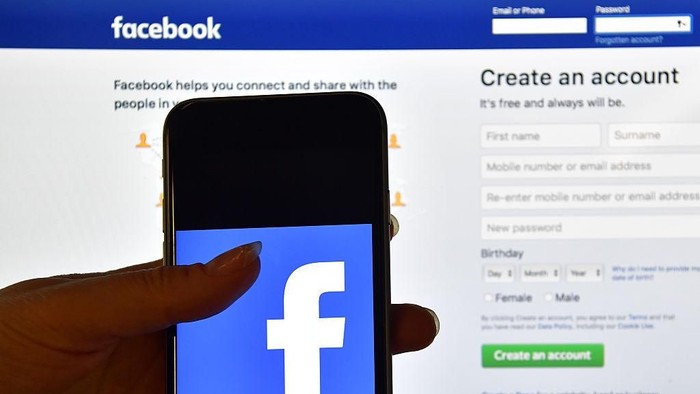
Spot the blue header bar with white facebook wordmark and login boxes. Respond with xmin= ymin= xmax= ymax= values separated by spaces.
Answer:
xmin=0 ymin=0 xmax=700 ymax=49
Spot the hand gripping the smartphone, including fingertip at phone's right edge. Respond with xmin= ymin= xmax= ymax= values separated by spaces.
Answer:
xmin=0 ymin=243 xmax=438 ymax=394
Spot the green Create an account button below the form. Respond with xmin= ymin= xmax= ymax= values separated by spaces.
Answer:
xmin=481 ymin=343 xmax=605 ymax=368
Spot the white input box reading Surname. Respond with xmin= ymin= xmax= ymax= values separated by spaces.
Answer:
xmin=608 ymin=123 xmax=700 ymax=147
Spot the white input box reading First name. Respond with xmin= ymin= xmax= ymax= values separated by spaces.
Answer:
xmin=481 ymin=124 xmax=601 ymax=148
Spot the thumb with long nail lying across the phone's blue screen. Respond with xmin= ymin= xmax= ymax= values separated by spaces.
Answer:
xmin=35 ymin=242 xmax=262 ymax=342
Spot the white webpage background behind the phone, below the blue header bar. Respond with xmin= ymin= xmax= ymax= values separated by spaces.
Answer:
xmin=0 ymin=48 xmax=700 ymax=394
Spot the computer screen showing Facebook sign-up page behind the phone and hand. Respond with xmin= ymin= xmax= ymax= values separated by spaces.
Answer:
xmin=0 ymin=0 xmax=700 ymax=394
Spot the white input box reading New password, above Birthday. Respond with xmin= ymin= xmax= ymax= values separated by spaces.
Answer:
xmin=481 ymin=215 xmax=700 ymax=240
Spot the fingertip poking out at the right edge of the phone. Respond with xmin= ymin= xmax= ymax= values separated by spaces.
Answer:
xmin=390 ymin=304 xmax=440 ymax=354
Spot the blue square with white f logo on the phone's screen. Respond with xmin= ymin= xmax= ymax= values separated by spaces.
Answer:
xmin=176 ymin=225 xmax=374 ymax=394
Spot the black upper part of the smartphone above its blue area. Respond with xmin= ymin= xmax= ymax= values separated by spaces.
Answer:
xmin=165 ymin=94 xmax=387 ymax=230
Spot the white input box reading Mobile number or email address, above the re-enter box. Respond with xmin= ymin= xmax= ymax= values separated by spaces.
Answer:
xmin=481 ymin=154 xmax=700 ymax=179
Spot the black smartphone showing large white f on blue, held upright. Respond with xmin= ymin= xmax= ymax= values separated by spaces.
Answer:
xmin=163 ymin=93 xmax=391 ymax=394
